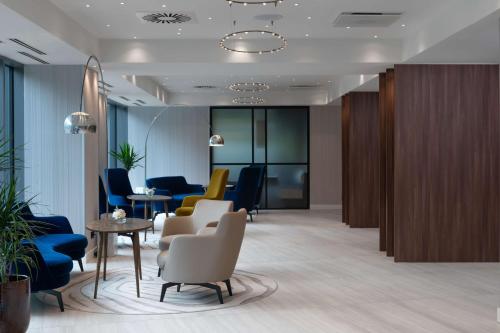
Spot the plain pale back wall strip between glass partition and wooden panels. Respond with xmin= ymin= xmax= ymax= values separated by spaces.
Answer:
xmin=310 ymin=105 xmax=342 ymax=208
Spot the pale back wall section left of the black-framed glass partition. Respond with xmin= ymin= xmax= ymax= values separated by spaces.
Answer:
xmin=128 ymin=107 xmax=210 ymax=188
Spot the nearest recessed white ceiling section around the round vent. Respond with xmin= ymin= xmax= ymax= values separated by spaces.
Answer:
xmin=50 ymin=0 xmax=455 ymax=39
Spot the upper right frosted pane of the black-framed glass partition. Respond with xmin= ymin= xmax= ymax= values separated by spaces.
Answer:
xmin=267 ymin=108 xmax=308 ymax=163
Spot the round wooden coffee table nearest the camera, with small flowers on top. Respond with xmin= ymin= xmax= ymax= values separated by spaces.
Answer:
xmin=86 ymin=218 xmax=153 ymax=298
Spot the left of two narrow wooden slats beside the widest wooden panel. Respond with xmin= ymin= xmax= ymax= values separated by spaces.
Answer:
xmin=378 ymin=73 xmax=387 ymax=251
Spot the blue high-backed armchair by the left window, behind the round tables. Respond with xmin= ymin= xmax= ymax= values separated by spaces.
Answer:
xmin=104 ymin=168 xmax=144 ymax=218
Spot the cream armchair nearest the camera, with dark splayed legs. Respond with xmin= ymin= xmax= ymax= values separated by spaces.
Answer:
xmin=157 ymin=209 xmax=247 ymax=304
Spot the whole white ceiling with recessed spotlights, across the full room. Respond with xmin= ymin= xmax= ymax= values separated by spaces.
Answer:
xmin=0 ymin=0 xmax=500 ymax=106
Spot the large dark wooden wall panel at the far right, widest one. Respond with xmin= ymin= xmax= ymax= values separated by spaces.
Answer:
xmin=394 ymin=65 xmax=500 ymax=262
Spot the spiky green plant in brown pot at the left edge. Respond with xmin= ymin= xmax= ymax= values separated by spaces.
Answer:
xmin=0 ymin=139 xmax=36 ymax=333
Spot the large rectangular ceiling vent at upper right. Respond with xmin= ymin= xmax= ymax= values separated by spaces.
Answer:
xmin=333 ymin=12 xmax=403 ymax=28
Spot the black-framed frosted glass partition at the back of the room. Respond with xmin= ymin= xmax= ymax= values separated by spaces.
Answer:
xmin=210 ymin=107 xmax=309 ymax=209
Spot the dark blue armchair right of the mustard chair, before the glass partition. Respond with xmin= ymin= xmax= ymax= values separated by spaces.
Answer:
xmin=224 ymin=166 xmax=261 ymax=221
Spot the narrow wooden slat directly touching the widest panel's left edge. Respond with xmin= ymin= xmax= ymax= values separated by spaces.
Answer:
xmin=385 ymin=69 xmax=395 ymax=257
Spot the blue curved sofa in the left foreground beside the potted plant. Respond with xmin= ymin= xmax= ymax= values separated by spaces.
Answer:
xmin=19 ymin=208 xmax=88 ymax=311
